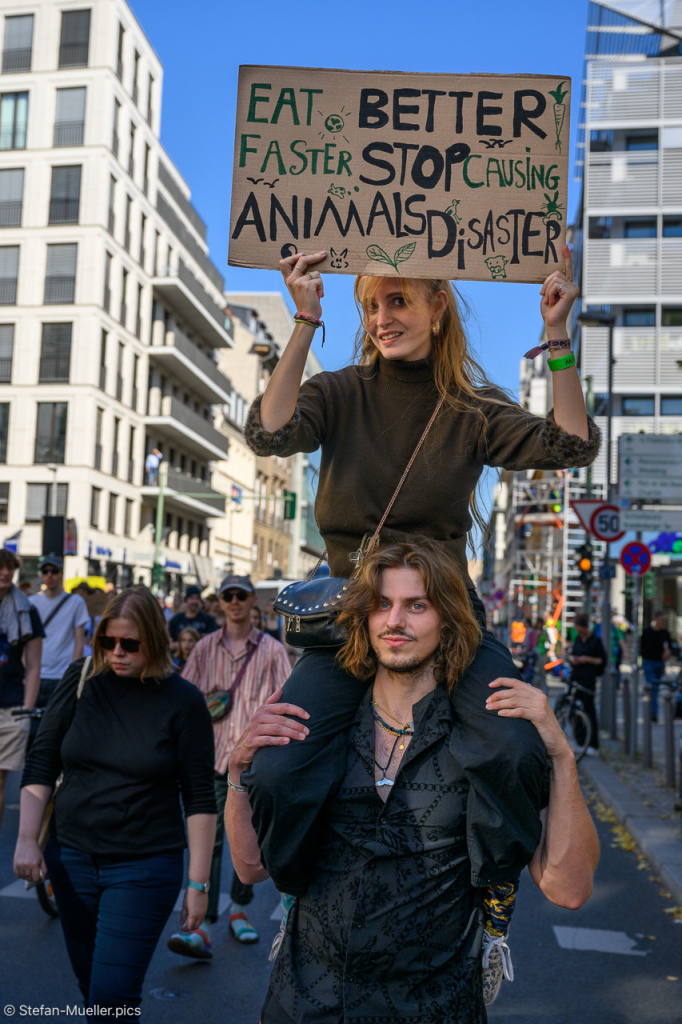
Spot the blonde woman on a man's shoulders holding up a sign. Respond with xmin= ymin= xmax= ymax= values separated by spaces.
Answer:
xmin=240 ymin=247 xmax=599 ymax=917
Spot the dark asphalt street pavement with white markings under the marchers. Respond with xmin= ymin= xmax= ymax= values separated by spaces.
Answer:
xmin=0 ymin=775 xmax=682 ymax=1024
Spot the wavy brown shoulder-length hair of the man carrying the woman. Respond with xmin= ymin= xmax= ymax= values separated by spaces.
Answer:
xmin=338 ymin=538 xmax=481 ymax=692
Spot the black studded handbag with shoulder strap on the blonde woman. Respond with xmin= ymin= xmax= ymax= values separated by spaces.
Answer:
xmin=272 ymin=397 xmax=443 ymax=650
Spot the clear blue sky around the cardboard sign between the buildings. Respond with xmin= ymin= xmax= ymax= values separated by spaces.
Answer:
xmin=132 ymin=0 xmax=587 ymax=390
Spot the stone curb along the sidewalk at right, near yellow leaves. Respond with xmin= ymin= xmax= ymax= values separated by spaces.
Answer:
xmin=579 ymin=758 xmax=682 ymax=906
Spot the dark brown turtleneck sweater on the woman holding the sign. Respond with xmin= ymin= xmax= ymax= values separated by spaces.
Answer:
xmin=246 ymin=356 xmax=600 ymax=587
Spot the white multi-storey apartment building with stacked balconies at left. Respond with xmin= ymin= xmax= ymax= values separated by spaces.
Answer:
xmin=0 ymin=0 xmax=233 ymax=588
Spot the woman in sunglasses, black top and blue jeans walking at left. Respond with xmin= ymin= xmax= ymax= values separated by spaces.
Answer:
xmin=14 ymin=587 xmax=216 ymax=1019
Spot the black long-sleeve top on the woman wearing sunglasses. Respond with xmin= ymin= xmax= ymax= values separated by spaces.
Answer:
xmin=22 ymin=660 xmax=215 ymax=857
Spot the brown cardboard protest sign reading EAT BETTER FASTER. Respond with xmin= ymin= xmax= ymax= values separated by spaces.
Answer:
xmin=229 ymin=67 xmax=570 ymax=282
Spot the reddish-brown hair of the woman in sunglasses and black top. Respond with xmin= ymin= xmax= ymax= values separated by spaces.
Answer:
xmin=90 ymin=587 xmax=174 ymax=682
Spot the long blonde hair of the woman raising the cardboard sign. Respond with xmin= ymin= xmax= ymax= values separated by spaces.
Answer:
xmin=353 ymin=276 xmax=503 ymax=550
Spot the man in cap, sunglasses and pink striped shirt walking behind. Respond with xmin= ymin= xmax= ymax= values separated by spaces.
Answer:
xmin=168 ymin=575 xmax=291 ymax=959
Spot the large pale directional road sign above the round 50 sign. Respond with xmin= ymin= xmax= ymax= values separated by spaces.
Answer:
xmin=619 ymin=434 xmax=682 ymax=502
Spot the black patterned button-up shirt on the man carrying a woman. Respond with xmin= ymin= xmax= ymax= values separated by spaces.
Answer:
xmin=270 ymin=686 xmax=486 ymax=1024
